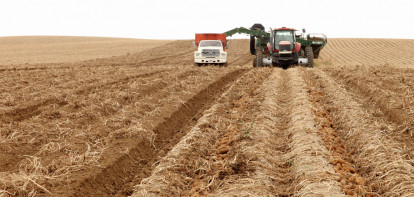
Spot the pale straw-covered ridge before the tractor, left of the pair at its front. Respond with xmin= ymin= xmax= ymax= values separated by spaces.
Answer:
xmin=211 ymin=68 xmax=294 ymax=196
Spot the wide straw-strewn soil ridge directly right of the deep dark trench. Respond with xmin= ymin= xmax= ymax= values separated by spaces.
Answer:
xmin=131 ymin=69 xmax=270 ymax=196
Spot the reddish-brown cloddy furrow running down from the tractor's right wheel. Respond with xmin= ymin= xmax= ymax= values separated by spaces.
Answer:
xmin=301 ymin=70 xmax=374 ymax=197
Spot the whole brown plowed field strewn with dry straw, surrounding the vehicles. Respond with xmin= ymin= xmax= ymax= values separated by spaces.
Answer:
xmin=0 ymin=38 xmax=414 ymax=197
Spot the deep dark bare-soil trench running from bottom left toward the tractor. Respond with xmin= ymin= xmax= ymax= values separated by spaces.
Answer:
xmin=68 ymin=69 xmax=246 ymax=196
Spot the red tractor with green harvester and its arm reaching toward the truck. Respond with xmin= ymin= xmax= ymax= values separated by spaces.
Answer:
xmin=225 ymin=23 xmax=327 ymax=67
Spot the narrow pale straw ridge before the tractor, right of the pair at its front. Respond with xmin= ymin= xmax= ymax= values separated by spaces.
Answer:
xmin=284 ymin=68 xmax=343 ymax=196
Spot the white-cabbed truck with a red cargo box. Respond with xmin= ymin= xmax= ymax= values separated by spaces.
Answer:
xmin=193 ymin=33 xmax=229 ymax=66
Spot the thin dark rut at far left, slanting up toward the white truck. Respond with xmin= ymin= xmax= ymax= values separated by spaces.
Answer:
xmin=0 ymin=70 xmax=168 ymax=124
